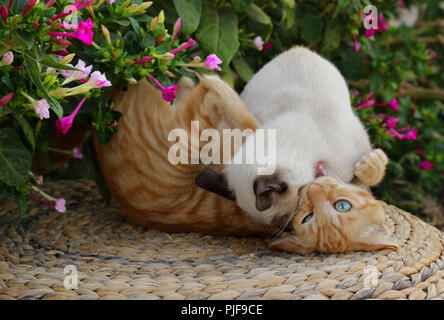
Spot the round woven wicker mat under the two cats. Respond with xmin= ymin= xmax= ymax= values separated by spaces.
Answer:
xmin=0 ymin=180 xmax=444 ymax=299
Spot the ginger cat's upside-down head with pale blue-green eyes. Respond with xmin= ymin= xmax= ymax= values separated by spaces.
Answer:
xmin=270 ymin=177 xmax=397 ymax=254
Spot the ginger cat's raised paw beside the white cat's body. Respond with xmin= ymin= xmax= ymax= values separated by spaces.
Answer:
xmin=355 ymin=149 xmax=388 ymax=186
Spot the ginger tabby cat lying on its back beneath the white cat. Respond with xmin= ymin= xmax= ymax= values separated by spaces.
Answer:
xmin=95 ymin=76 xmax=392 ymax=252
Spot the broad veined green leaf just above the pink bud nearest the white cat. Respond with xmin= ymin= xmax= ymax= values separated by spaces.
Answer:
xmin=196 ymin=2 xmax=239 ymax=65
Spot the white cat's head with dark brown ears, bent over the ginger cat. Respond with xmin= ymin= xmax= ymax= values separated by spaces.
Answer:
xmin=196 ymin=131 xmax=315 ymax=227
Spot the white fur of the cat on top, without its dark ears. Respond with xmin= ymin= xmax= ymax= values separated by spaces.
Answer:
xmin=225 ymin=47 xmax=371 ymax=224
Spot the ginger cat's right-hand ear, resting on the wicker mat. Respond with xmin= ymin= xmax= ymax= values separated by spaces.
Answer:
xmin=353 ymin=224 xmax=398 ymax=251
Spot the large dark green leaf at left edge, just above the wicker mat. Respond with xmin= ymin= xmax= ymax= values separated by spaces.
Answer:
xmin=0 ymin=128 xmax=31 ymax=186
